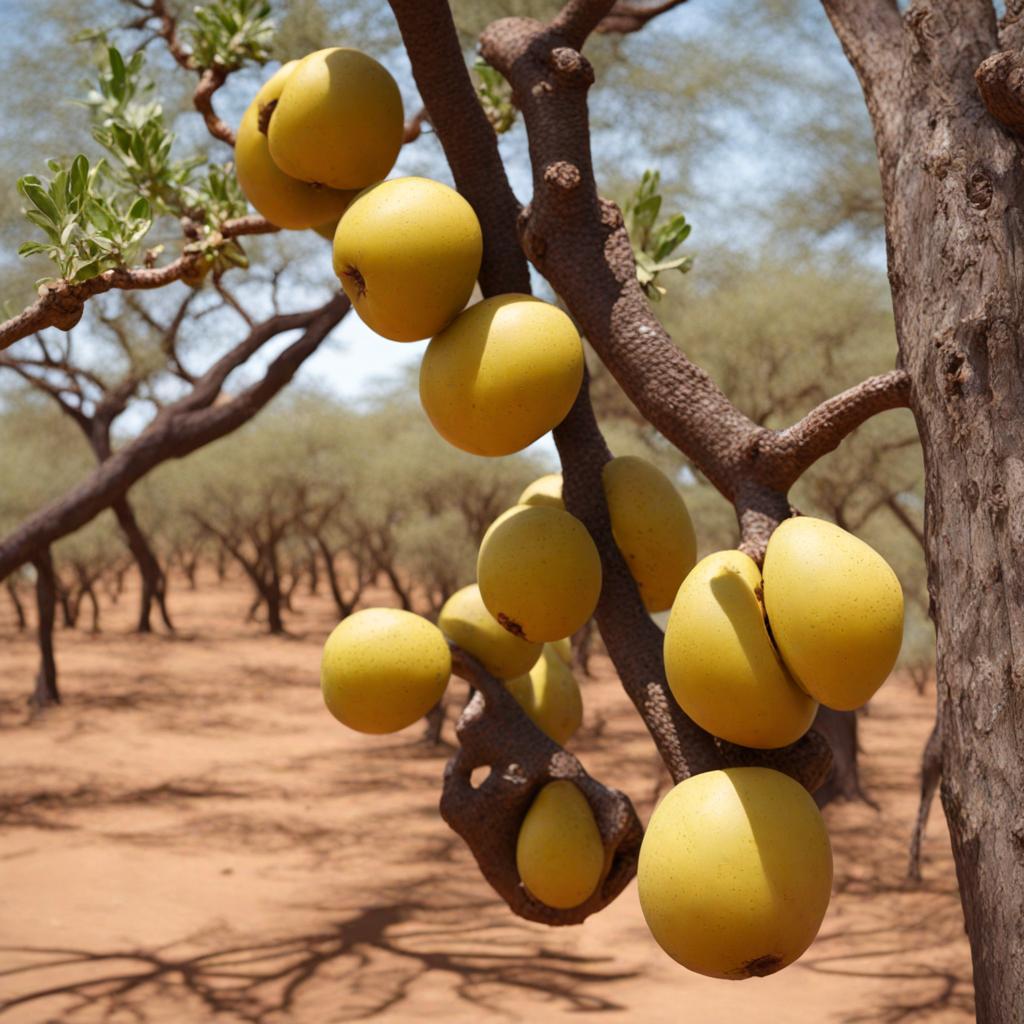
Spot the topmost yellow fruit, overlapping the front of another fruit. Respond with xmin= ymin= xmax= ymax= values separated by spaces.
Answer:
xmin=267 ymin=47 xmax=404 ymax=192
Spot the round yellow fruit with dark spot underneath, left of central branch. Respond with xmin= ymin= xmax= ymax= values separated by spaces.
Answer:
xmin=476 ymin=505 xmax=601 ymax=643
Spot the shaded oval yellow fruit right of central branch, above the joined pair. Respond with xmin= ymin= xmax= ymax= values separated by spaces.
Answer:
xmin=601 ymin=455 xmax=697 ymax=611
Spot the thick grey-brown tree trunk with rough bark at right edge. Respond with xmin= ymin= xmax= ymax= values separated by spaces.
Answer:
xmin=825 ymin=0 xmax=1024 ymax=1024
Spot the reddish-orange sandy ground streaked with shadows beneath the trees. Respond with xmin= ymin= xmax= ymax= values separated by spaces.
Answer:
xmin=0 ymin=581 xmax=974 ymax=1024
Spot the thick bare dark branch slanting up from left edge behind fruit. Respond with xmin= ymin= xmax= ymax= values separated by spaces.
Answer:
xmin=0 ymin=292 xmax=349 ymax=580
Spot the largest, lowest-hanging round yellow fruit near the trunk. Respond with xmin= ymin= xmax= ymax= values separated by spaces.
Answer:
xmin=637 ymin=768 xmax=833 ymax=980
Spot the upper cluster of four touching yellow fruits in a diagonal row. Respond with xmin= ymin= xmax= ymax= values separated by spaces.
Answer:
xmin=234 ymin=47 xmax=584 ymax=457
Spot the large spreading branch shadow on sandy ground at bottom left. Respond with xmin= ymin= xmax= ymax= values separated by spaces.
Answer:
xmin=0 ymin=902 xmax=636 ymax=1024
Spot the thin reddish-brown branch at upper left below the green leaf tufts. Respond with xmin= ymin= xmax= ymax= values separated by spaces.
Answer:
xmin=0 ymin=214 xmax=281 ymax=350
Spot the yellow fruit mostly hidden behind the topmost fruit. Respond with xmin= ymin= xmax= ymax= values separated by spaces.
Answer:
xmin=234 ymin=60 xmax=355 ymax=230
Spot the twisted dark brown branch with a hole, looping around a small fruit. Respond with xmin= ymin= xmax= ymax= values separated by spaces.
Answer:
xmin=440 ymin=643 xmax=643 ymax=925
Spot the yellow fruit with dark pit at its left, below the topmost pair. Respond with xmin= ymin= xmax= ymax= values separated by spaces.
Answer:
xmin=334 ymin=178 xmax=483 ymax=341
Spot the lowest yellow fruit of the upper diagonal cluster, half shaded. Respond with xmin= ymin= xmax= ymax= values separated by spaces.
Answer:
xmin=417 ymin=296 xmax=584 ymax=457
